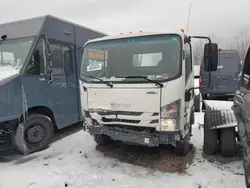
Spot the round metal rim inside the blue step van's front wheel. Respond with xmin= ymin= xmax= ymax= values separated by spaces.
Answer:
xmin=26 ymin=125 xmax=45 ymax=144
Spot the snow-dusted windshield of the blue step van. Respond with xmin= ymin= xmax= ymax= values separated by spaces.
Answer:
xmin=0 ymin=37 xmax=34 ymax=70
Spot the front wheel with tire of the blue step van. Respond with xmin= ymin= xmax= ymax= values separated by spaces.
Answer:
xmin=14 ymin=114 xmax=54 ymax=155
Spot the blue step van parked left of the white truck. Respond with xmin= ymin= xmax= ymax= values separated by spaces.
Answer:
xmin=0 ymin=15 xmax=106 ymax=154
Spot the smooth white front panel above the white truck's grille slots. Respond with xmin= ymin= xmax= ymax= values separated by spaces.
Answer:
xmin=88 ymin=88 xmax=161 ymax=113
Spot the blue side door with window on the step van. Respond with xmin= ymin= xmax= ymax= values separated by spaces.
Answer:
xmin=49 ymin=41 xmax=79 ymax=128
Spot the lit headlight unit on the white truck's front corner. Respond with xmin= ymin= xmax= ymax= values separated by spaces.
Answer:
xmin=161 ymin=99 xmax=181 ymax=131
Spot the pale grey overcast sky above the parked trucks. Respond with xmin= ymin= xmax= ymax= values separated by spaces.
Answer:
xmin=0 ymin=0 xmax=250 ymax=37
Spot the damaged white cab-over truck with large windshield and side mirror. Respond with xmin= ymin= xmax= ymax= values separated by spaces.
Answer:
xmin=80 ymin=32 xmax=218 ymax=155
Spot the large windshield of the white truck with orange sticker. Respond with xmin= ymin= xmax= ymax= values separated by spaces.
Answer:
xmin=81 ymin=35 xmax=182 ymax=83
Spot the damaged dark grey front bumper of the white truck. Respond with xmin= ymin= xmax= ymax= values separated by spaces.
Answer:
xmin=88 ymin=126 xmax=180 ymax=147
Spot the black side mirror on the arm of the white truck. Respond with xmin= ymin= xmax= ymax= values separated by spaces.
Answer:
xmin=203 ymin=43 xmax=218 ymax=72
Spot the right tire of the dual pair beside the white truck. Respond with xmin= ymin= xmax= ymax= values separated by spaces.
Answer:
xmin=220 ymin=127 xmax=236 ymax=157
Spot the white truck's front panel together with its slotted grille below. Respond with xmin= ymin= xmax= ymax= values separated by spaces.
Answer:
xmin=87 ymin=88 xmax=161 ymax=128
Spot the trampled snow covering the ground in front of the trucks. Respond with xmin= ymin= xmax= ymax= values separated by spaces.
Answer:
xmin=0 ymin=113 xmax=245 ymax=188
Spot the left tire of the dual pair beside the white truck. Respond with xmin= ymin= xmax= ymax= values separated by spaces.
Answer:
xmin=203 ymin=111 xmax=219 ymax=154
